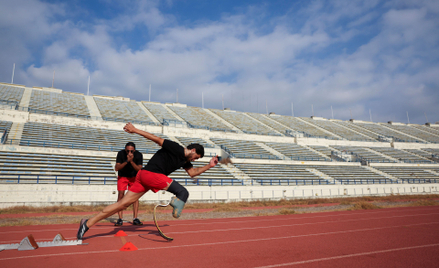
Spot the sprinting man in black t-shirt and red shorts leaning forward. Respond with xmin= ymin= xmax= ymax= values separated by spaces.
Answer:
xmin=76 ymin=123 xmax=218 ymax=240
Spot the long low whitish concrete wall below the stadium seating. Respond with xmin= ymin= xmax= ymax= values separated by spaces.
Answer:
xmin=0 ymin=184 xmax=439 ymax=208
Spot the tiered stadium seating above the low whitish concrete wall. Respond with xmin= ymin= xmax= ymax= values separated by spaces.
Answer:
xmin=0 ymin=84 xmax=439 ymax=186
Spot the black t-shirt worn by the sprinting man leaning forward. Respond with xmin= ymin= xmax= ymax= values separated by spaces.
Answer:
xmin=143 ymin=140 xmax=192 ymax=176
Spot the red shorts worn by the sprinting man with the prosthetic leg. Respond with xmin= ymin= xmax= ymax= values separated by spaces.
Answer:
xmin=130 ymin=169 xmax=172 ymax=193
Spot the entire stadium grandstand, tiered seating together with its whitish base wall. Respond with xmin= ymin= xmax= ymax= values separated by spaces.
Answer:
xmin=0 ymin=83 xmax=439 ymax=207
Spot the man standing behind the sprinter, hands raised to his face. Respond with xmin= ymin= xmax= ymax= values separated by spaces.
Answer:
xmin=114 ymin=142 xmax=143 ymax=226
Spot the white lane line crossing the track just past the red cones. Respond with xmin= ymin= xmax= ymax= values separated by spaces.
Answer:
xmin=0 ymin=222 xmax=439 ymax=261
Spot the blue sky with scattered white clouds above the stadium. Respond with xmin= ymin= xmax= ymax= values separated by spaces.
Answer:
xmin=0 ymin=0 xmax=439 ymax=124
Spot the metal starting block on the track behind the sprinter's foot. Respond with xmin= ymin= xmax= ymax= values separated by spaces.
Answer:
xmin=0 ymin=233 xmax=88 ymax=251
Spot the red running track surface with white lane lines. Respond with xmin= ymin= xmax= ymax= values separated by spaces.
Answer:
xmin=0 ymin=206 xmax=439 ymax=268
